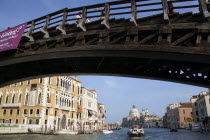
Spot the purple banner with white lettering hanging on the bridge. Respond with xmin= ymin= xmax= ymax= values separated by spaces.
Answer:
xmin=0 ymin=23 xmax=27 ymax=52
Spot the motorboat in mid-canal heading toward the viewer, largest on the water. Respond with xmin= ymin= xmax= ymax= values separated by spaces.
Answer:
xmin=128 ymin=125 xmax=144 ymax=137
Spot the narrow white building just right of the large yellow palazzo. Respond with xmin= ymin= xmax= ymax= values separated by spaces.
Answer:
xmin=81 ymin=87 xmax=98 ymax=131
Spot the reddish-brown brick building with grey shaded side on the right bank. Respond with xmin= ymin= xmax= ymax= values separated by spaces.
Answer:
xmin=166 ymin=103 xmax=192 ymax=128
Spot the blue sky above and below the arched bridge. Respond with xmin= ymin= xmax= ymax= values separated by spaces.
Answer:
xmin=0 ymin=0 xmax=207 ymax=123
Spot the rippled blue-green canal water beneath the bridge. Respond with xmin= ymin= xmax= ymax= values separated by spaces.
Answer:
xmin=0 ymin=128 xmax=210 ymax=140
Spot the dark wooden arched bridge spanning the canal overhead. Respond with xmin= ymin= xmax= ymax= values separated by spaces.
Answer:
xmin=0 ymin=0 xmax=210 ymax=87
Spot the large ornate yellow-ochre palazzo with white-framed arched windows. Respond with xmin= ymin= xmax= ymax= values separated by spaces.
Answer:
xmin=0 ymin=76 xmax=81 ymax=130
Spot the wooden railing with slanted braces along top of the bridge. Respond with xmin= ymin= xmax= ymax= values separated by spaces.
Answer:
xmin=24 ymin=0 xmax=208 ymax=41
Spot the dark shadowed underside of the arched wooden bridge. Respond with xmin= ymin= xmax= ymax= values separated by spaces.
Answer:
xmin=0 ymin=50 xmax=210 ymax=87
